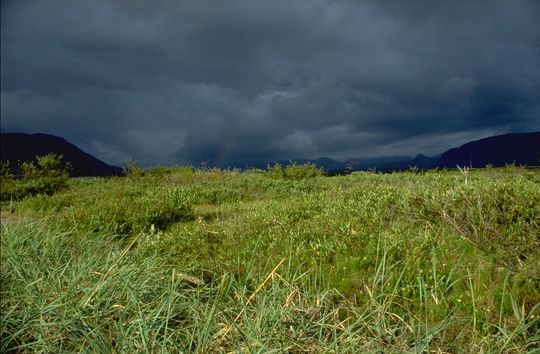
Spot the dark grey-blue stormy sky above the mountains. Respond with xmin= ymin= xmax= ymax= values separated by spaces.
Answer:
xmin=1 ymin=0 xmax=540 ymax=166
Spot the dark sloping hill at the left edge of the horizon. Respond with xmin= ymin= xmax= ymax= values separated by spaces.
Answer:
xmin=1 ymin=133 xmax=122 ymax=176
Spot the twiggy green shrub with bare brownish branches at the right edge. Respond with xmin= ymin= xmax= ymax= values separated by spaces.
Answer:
xmin=442 ymin=178 xmax=540 ymax=279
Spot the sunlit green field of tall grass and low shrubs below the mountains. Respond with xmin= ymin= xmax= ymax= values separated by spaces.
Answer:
xmin=0 ymin=166 xmax=540 ymax=353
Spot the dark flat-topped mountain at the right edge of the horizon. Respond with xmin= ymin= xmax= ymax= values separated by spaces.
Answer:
xmin=437 ymin=132 xmax=540 ymax=168
